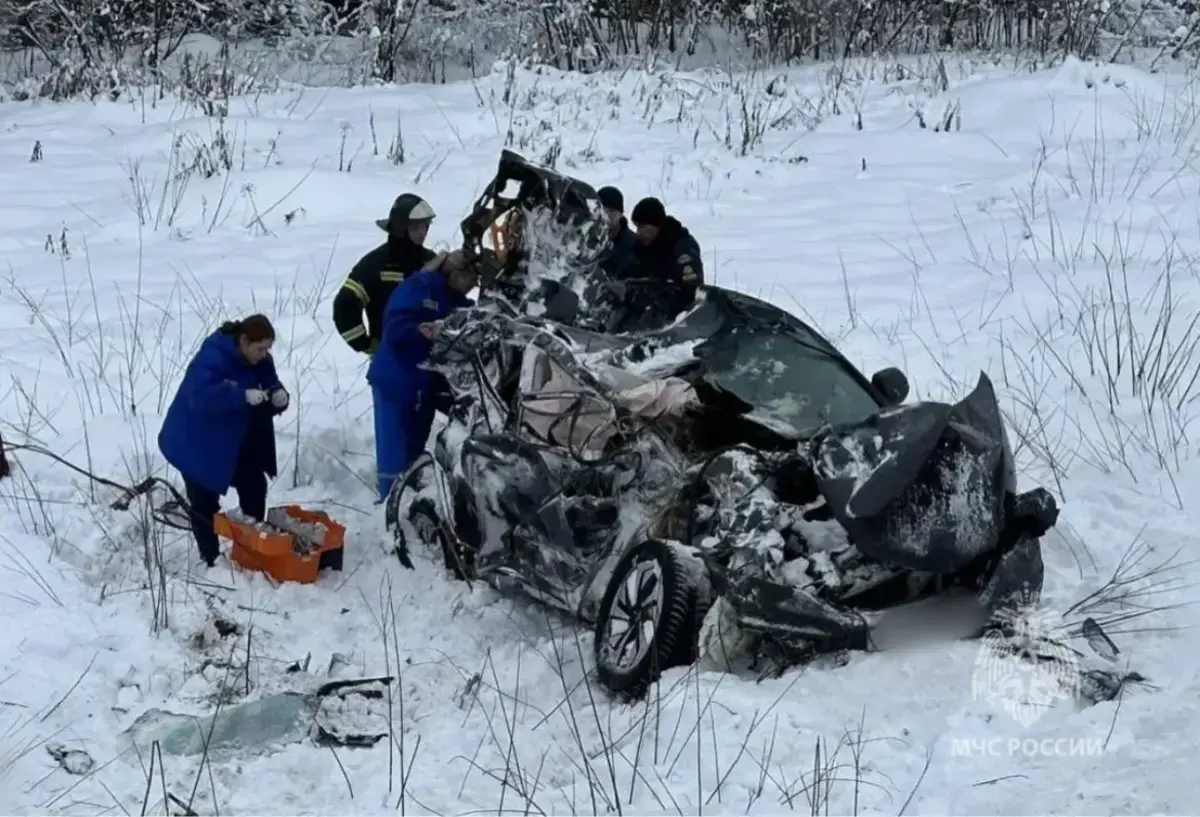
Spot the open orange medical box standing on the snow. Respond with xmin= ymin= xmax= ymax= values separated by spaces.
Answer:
xmin=212 ymin=505 xmax=346 ymax=584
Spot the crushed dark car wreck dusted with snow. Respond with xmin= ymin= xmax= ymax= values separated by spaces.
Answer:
xmin=386 ymin=154 xmax=1057 ymax=696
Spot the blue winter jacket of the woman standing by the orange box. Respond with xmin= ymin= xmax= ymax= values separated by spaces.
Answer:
xmin=158 ymin=331 xmax=282 ymax=494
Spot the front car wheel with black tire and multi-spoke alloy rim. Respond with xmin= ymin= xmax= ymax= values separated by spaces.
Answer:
xmin=595 ymin=539 xmax=701 ymax=699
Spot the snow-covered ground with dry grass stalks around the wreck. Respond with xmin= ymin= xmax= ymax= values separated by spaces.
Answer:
xmin=0 ymin=59 xmax=1200 ymax=815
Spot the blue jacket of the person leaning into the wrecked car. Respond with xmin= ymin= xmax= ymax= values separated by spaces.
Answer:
xmin=367 ymin=270 xmax=472 ymax=404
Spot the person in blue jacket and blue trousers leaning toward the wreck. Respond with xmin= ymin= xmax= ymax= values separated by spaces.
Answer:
xmin=367 ymin=252 xmax=479 ymax=501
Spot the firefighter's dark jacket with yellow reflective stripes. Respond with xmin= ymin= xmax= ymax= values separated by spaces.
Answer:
xmin=334 ymin=236 xmax=437 ymax=352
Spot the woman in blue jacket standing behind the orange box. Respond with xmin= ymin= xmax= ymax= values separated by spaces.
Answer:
xmin=158 ymin=314 xmax=289 ymax=567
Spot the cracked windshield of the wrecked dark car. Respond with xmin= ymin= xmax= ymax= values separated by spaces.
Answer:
xmin=696 ymin=331 xmax=880 ymax=433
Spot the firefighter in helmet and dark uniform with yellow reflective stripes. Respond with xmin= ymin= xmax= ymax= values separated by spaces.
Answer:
xmin=334 ymin=193 xmax=437 ymax=355
